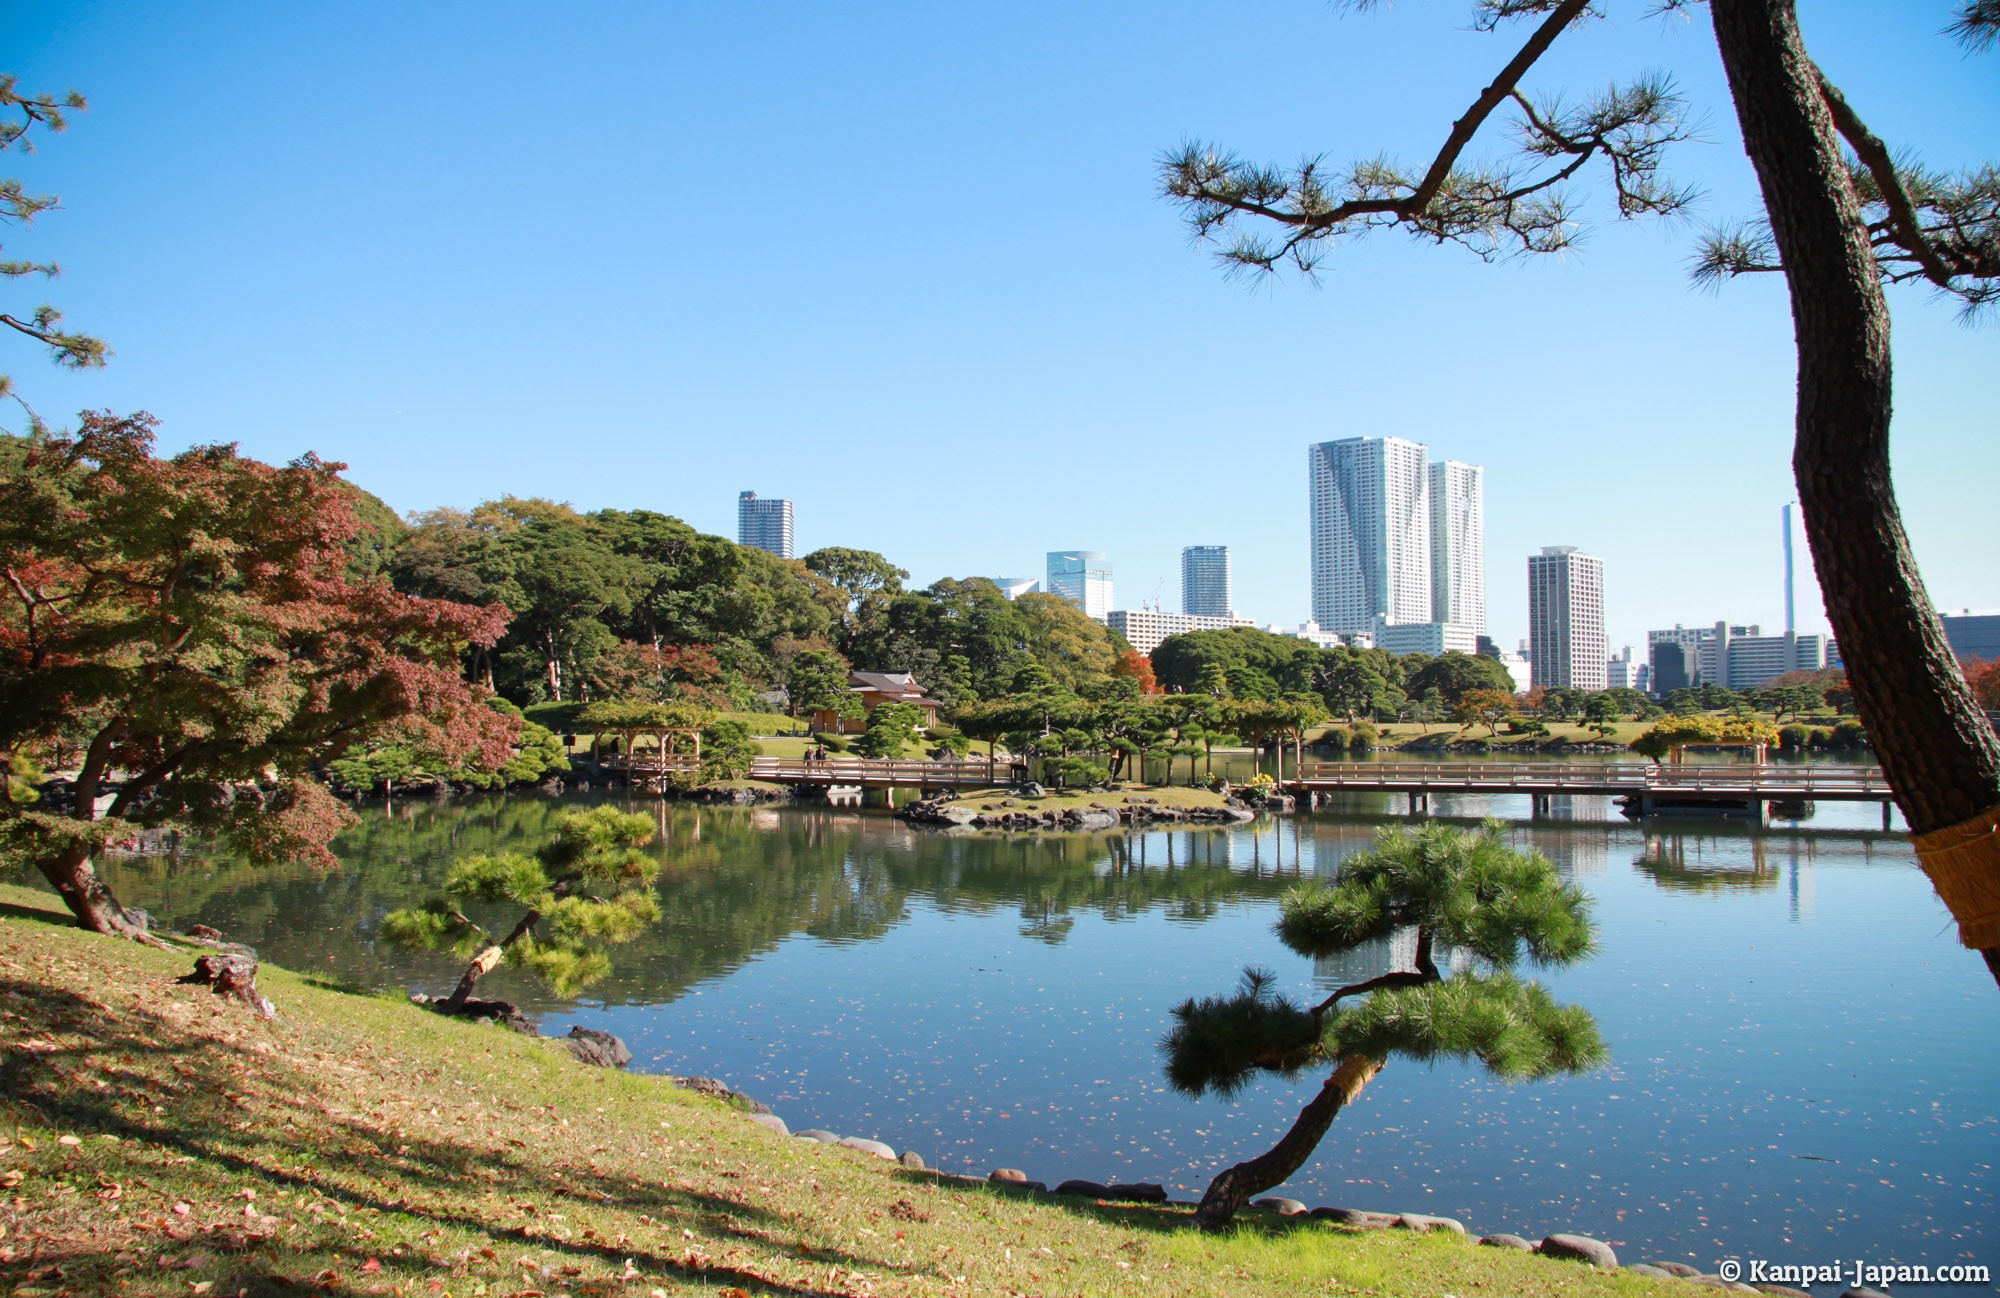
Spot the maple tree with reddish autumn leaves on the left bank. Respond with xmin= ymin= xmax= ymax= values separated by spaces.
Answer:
xmin=0 ymin=414 xmax=516 ymax=936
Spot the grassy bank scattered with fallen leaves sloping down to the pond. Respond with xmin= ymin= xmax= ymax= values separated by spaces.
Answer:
xmin=0 ymin=888 xmax=1666 ymax=1298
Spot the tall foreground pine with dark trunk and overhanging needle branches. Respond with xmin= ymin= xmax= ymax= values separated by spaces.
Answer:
xmin=1160 ymin=0 xmax=2000 ymax=982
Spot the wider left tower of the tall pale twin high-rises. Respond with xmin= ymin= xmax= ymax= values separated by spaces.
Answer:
xmin=1306 ymin=438 xmax=1432 ymax=634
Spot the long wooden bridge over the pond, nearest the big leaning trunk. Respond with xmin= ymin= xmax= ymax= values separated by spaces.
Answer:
xmin=1286 ymin=762 xmax=1894 ymax=826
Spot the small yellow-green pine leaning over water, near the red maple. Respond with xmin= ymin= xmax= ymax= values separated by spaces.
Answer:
xmin=382 ymin=806 xmax=660 ymax=1014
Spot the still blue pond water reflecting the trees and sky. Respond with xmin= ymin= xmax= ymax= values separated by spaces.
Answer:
xmin=86 ymin=796 xmax=2000 ymax=1294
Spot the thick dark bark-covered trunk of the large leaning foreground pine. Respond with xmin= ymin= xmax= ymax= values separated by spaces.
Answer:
xmin=1710 ymin=0 xmax=2000 ymax=956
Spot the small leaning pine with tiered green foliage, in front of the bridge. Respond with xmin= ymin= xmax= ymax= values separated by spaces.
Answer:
xmin=1160 ymin=824 xmax=1604 ymax=1230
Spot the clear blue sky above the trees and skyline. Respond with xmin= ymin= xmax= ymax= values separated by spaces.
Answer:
xmin=0 ymin=0 xmax=2000 ymax=644
